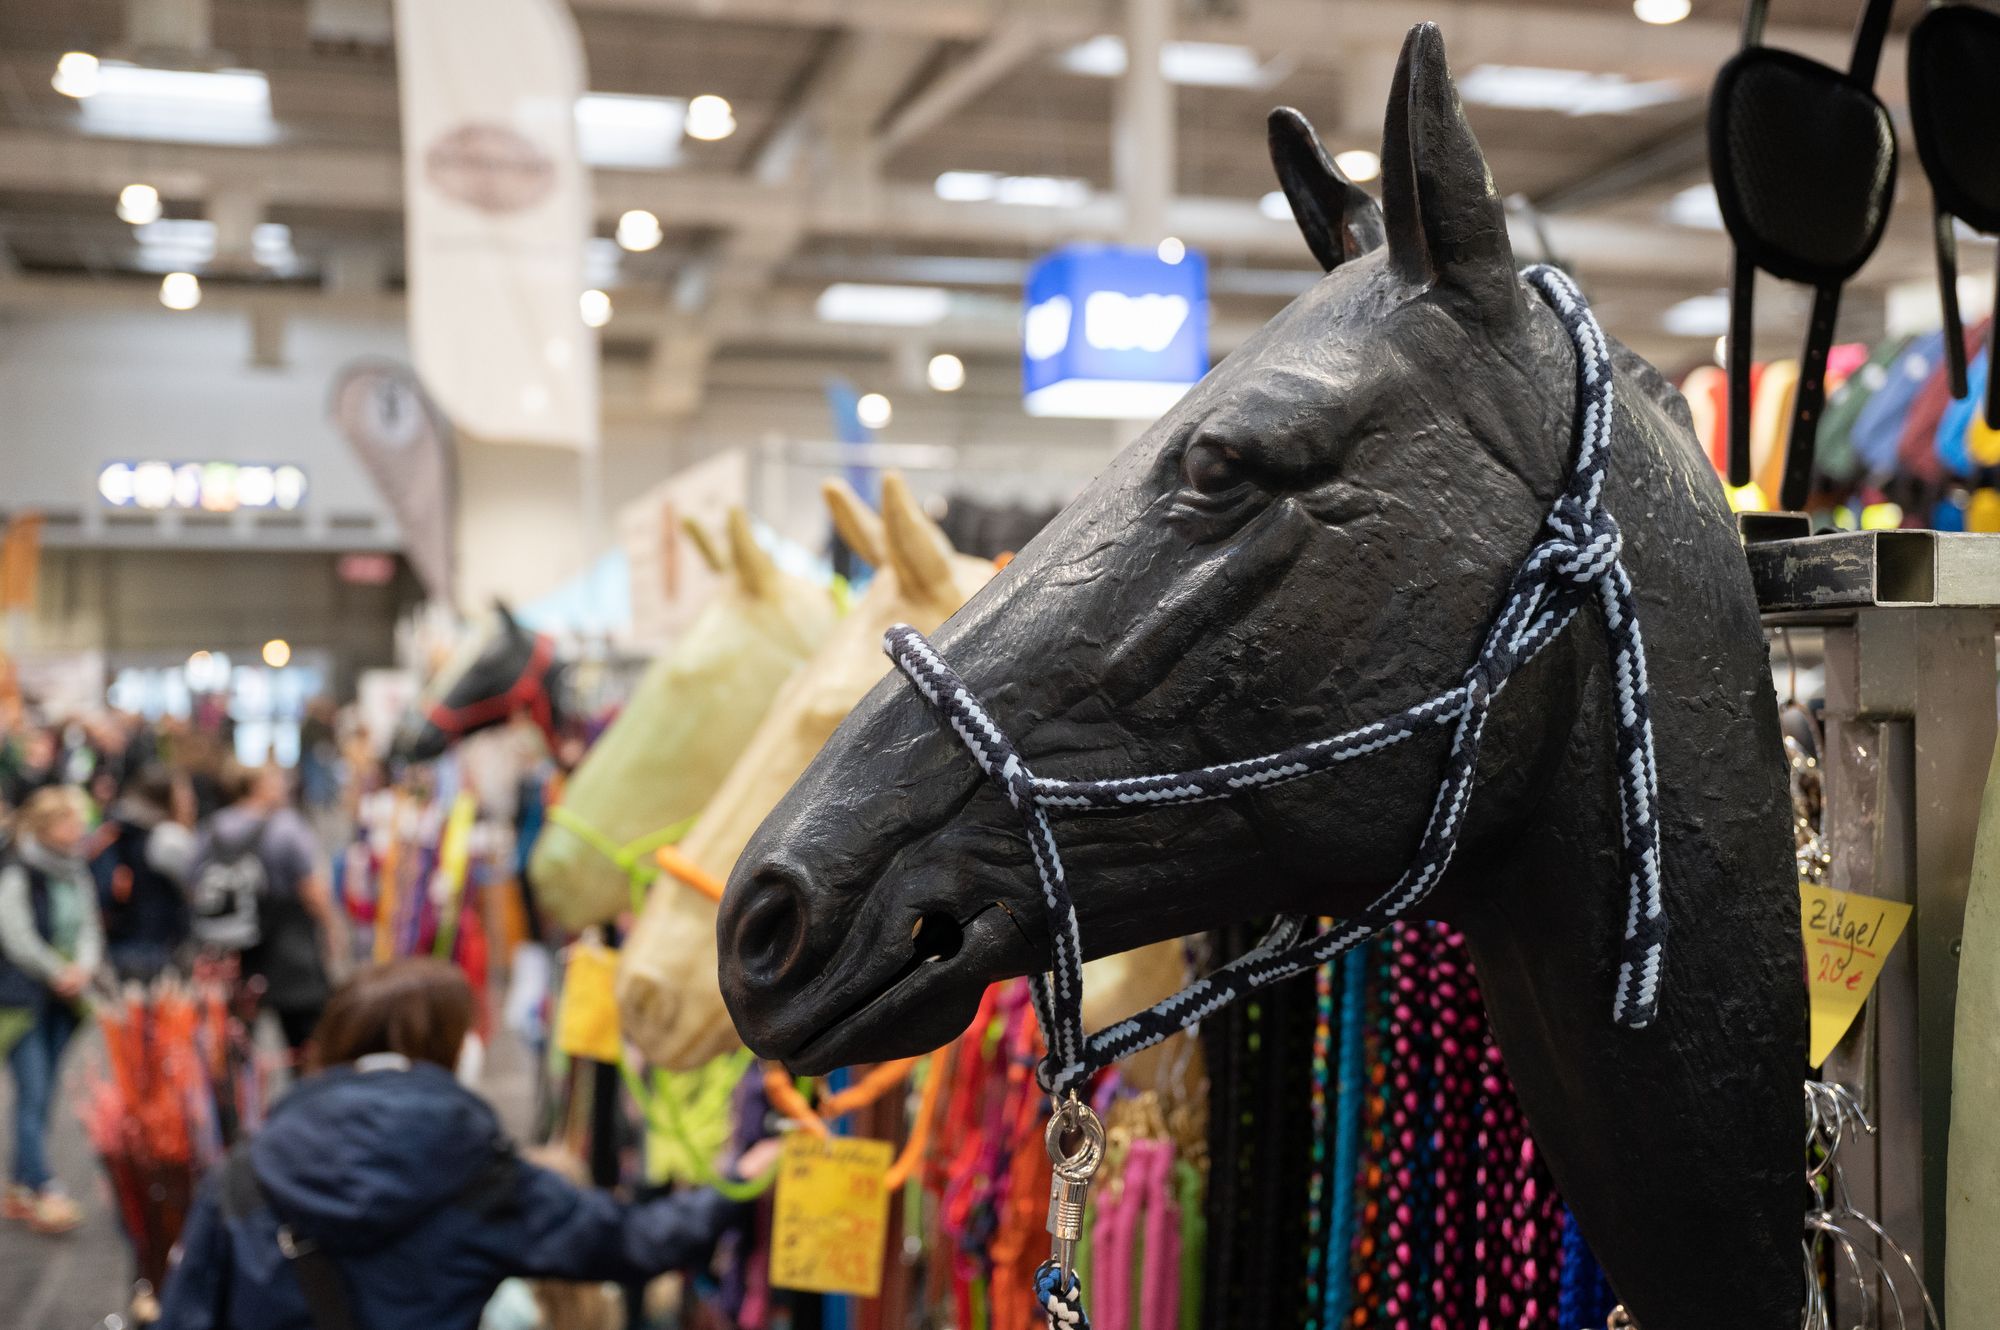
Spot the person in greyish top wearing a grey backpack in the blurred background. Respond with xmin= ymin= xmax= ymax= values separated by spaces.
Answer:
xmin=188 ymin=766 xmax=340 ymax=1054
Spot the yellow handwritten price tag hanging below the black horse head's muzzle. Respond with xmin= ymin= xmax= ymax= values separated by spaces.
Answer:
xmin=770 ymin=1132 xmax=892 ymax=1298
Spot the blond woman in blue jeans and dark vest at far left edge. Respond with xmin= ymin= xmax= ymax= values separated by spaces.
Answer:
xmin=0 ymin=786 xmax=104 ymax=1234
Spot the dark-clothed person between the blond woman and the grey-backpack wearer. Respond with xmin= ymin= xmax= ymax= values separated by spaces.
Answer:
xmin=90 ymin=766 xmax=194 ymax=982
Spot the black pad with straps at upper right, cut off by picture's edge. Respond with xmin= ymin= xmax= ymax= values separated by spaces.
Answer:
xmin=1910 ymin=4 xmax=2000 ymax=426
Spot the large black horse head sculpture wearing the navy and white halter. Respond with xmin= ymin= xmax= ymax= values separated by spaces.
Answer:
xmin=718 ymin=26 xmax=1806 ymax=1330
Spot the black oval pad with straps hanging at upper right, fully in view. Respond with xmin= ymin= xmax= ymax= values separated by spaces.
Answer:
xmin=1708 ymin=0 xmax=1896 ymax=508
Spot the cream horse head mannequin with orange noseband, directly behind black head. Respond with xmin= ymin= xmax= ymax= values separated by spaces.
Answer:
xmin=618 ymin=472 xmax=1184 ymax=1070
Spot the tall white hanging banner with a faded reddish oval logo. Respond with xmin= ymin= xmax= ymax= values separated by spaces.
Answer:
xmin=396 ymin=0 xmax=598 ymax=448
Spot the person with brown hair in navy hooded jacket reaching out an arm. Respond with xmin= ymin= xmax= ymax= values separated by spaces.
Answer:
xmin=158 ymin=958 xmax=774 ymax=1330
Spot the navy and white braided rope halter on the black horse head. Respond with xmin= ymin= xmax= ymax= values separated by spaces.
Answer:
xmin=884 ymin=264 xmax=1666 ymax=1098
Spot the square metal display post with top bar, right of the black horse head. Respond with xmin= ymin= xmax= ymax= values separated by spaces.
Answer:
xmin=1746 ymin=532 xmax=2000 ymax=1326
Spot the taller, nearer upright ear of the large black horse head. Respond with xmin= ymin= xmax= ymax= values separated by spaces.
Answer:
xmin=1382 ymin=24 xmax=1520 ymax=318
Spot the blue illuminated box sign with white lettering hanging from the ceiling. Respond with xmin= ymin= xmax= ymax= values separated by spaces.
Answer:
xmin=1020 ymin=244 xmax=1208 ymax=420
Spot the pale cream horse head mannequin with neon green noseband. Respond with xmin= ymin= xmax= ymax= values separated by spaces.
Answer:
xmin=530 ymin=508 xmax=836 ymax=930
